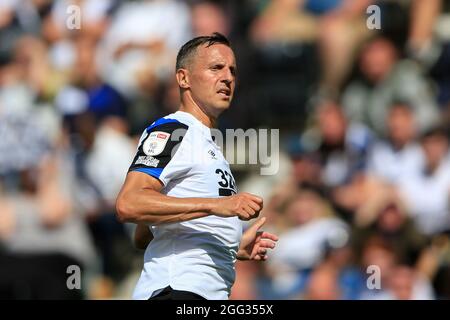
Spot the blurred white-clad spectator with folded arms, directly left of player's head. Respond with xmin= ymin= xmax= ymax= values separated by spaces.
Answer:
xmin=99 ymin=0 xmax=191 ymax=98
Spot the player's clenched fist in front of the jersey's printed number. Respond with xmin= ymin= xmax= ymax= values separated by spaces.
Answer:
xmin=212 ymin=192 xmax=263 ymax=220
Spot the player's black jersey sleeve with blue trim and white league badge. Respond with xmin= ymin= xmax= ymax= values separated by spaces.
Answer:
xmin=128 ymin=118 xmax=190 ymax=185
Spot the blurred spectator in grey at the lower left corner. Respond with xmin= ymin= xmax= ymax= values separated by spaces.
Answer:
xmin=0 ymin=128 xmax=95 ymax=299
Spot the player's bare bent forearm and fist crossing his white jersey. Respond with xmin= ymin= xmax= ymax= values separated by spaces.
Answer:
xmin=116 ymin=172 xmax=262 ymax=225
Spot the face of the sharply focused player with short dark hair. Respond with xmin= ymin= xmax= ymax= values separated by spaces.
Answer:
xmin=189 ymin=44 xmax=236 ymax=117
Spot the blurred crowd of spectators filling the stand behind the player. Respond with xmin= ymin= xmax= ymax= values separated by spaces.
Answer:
xmin=0 ymin=0 xmax=450 ymax=299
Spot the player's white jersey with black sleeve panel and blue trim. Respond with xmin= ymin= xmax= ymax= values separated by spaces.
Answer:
xmin=130 ymin=111 xmax=242 ymax=300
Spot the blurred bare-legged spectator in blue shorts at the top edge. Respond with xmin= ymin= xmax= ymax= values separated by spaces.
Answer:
xmin=250 ymin=0 xmax=374 ymax=98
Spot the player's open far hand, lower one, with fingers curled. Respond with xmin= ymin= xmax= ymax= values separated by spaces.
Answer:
xmin=237 ymin=217 xmax=278 ymax=261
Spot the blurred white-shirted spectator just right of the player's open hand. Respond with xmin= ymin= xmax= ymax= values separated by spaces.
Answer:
xmin=267 ymin=190 xmax=348 ymax=299
